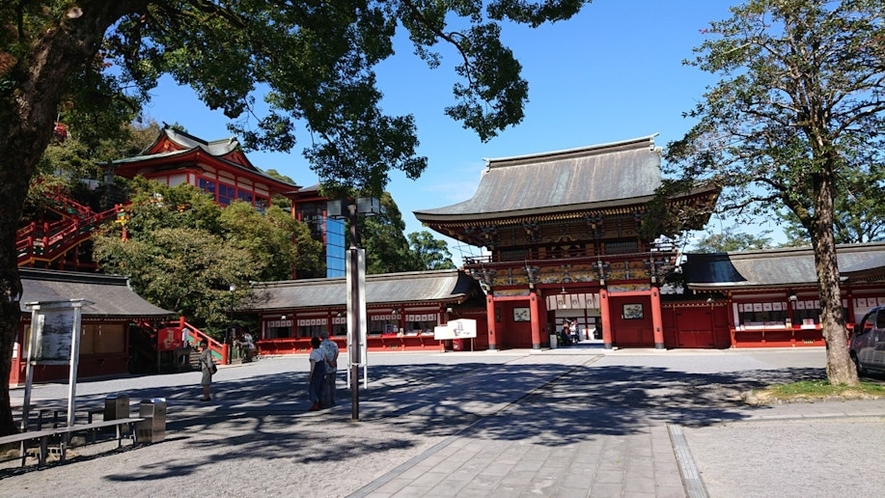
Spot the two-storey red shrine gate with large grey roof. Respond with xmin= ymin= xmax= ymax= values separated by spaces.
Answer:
xmin=415 ymin=135 xmax=719 ymax=349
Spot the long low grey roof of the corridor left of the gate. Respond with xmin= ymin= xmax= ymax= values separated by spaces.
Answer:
xmin=240 ymin=270 xmax=482 ymax=311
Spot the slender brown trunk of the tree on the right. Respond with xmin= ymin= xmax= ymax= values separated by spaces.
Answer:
xmin=811 ymin=168 xmax=860 ymax=386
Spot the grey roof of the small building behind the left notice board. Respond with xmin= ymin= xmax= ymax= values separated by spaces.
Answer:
xmin=19 ymin=268 xmax=175 ymax=318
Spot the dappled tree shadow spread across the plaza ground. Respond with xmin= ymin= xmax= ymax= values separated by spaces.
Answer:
xmin=0 ymin=361 xmax=825 ymax=480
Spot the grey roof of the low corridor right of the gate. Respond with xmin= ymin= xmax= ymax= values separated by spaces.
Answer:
xmin=682 ymin=243 xmax=885 ymax=290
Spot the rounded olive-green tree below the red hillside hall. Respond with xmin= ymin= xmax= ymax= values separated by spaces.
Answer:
xmin=93 ymin=178 xmax=322 ymax=329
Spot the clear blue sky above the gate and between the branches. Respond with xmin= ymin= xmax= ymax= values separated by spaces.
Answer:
xmin=138 ymin=0 xmax=776 ymax=256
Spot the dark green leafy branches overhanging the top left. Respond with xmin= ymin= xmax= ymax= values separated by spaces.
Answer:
xmin=6 ymin=0 xmax=589 ymax=197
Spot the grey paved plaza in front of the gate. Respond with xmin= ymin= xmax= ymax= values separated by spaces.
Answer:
xmin=0 ymin=344 xmax=885 ymax=498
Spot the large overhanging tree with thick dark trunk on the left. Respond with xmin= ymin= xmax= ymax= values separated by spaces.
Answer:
xmin=0 ymin=0 xmax=590 ymax=434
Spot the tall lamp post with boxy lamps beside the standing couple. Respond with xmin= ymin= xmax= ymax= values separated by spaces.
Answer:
xmin=326 ymin=197 xmax=381 ymax=420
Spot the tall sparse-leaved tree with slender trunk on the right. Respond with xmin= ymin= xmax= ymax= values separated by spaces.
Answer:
xmin=666 ymin=0 xmax=885 ymax=385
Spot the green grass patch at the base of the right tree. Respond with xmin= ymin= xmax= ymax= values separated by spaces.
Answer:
xmin=747 ymin=380 xmax=885 ymax=404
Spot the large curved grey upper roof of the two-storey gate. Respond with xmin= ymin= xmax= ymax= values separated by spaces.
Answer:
xmin=415 ymin=135 xmax=661 ymax=221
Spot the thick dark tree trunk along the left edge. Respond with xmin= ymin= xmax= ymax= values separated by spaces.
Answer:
xmin=0 ymin=0 xmax=141 ymax=435
